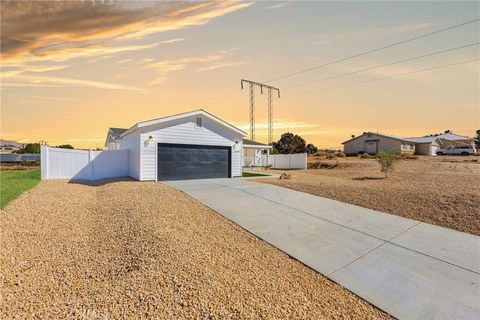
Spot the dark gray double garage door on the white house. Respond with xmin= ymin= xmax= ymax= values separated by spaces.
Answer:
xmin=157 ymin=143 xmax=231 ymax=181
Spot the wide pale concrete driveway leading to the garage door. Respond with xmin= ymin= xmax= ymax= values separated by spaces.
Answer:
xmin=166 ymin=179 xmax=480 ymax=319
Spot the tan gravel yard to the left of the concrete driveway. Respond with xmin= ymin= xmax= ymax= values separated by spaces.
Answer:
xmin=0 ymin=180 xmax=389 ymax=319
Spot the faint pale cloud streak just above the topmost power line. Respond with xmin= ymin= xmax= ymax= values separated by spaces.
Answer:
xmin=293 ymin=23 xmax=431 ymax=45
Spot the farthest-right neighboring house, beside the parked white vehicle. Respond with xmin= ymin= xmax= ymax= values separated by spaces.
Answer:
xmin=407 ymin=133 xmax=474 ymax=156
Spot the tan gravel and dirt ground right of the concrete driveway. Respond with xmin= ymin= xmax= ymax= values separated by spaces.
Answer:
xmin=256 ymin=156 xmax=480 ymax=235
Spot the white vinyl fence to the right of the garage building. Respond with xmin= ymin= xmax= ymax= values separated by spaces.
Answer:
xmin=243 ymin=153 xmax=307 ymax=169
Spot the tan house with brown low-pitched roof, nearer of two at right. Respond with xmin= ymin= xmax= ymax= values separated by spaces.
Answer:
xmin=342 ymin=132 xmax=415 ymax=155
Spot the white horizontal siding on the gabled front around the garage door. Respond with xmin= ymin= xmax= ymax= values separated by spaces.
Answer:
xmin=137 ymin=116 xmax=242 ymax=180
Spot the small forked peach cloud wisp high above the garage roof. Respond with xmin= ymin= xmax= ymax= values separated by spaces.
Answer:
xmin=147 ymin=55 xmax=223 ymax=84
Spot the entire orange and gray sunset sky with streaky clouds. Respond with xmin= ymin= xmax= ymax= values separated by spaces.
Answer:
xmin=1 ymin=1 xmax=480 ymax=148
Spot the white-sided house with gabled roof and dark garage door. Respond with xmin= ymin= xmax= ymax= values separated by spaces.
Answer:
xmin=105 ymin=109 xmax=247 ymax=181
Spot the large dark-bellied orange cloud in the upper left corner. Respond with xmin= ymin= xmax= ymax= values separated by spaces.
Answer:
xmin=0 ymin=1 xmax=252 ymax=61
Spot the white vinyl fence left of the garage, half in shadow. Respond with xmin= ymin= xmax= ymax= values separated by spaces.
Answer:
xmin=40 ymin=146 xmax=128 ymax=180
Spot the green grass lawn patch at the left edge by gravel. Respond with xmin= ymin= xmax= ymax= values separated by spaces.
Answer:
xmin=0 ymin=169 xmax=40 ymax=209
